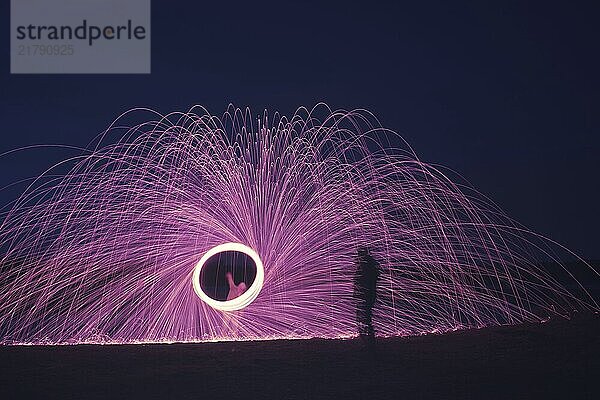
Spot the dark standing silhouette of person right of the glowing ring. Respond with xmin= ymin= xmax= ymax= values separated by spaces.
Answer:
xmin=354 ymin=248 xmax=379 ymax=343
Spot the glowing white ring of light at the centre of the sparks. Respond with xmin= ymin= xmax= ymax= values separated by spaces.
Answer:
xmin=192 ymin=243 xmax=265 ymax=311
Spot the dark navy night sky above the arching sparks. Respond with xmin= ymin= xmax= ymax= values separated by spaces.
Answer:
xmin=0 ymin=1 xmax=600 ymax=258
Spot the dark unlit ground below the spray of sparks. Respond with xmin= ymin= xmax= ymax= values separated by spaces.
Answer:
xmin=0 ymin=316 xmax=600 ymax=399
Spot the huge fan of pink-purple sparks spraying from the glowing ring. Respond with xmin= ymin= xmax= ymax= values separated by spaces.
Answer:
xmin=0 ymin=105 xmax=598 ymax=343
